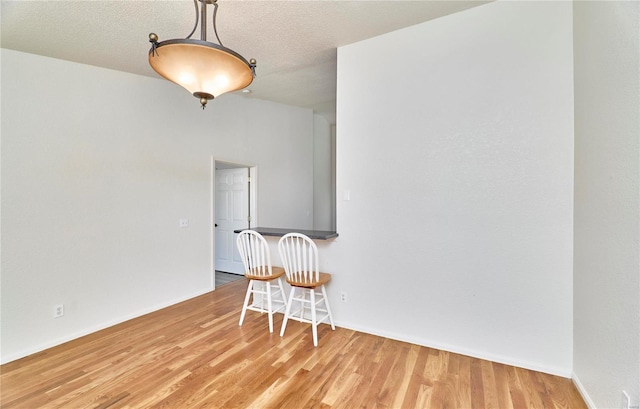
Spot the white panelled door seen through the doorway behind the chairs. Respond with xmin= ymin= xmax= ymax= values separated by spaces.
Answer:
xmin=215 ymin=168 xmax=249 ymax=274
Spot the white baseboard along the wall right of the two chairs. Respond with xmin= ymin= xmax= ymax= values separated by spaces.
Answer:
xmin=335 ymin=321 xmax=571 ymax=379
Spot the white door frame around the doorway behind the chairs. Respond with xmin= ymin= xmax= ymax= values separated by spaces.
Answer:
xmin=209 ymin=155 xmax=258 ymax=290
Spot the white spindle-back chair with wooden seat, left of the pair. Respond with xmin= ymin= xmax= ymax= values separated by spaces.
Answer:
xmin=236 ymin=230 xmax=286 ymax=332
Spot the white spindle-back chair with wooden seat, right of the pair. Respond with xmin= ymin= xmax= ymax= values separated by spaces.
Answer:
xmin=278 ymin=233 xmax=336 ymax=347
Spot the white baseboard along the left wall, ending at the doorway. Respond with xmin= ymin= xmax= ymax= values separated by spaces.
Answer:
xmin=0 ymin=288 xmax=212 ymax=365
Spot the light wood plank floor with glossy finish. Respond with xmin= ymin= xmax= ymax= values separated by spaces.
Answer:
xmin=0 ymin=280 xmax=586 ymax=409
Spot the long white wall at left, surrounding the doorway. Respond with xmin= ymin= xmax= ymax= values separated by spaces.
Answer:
xmin=1 ymin=49 xmax=314 ymax=362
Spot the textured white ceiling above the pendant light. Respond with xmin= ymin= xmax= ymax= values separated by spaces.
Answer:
xmin=0 ymin=0 xmax=487 ymax=123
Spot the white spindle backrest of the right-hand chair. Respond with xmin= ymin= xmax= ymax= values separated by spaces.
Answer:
xmin=278 ymin=233 xmax=320 ymax=283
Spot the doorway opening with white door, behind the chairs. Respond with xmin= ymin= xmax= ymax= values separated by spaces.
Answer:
xmin=212 ymin=160 xmax=256 ymax=281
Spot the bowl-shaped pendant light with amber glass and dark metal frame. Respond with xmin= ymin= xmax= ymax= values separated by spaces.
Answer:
xmin=149 ymin=0 xmax=256 ymax=109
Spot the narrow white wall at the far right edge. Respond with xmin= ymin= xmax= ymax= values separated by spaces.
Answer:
xmin=574 ymin=1 xmax=640 ymax=408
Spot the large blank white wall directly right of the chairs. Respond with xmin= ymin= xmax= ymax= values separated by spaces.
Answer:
xmin=330 ymin=2 xmax=573 ymax=376
